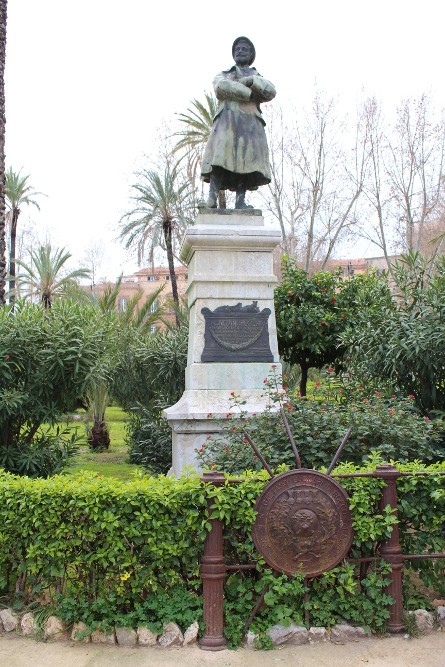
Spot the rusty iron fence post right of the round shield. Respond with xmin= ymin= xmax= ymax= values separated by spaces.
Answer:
xmin=375 ymin=464 xmax=405 ymax=633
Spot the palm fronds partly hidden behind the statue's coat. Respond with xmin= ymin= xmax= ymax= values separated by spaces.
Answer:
xmin=173 ymin=92 xmax=226 ymax=208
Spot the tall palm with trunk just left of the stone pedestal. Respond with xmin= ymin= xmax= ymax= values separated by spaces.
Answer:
xmin=120 ymin=162 xmax=191 ymax=324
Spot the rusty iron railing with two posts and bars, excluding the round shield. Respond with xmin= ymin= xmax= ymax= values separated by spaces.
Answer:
xmin=199 ymin=464 xmax=445 ymax=651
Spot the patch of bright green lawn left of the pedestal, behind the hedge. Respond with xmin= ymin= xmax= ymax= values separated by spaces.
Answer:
xmin=62 ymin=407 xmax=138 ymax=480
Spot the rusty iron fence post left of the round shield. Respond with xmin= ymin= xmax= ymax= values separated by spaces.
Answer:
xmin=199 ymin=471 xmax=227 ymax=651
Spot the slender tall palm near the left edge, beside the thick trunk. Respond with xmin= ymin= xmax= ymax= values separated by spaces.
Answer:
xmin=5 ymin=167 xmax=42 ymax=303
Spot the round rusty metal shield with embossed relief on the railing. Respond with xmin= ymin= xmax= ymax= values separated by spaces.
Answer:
xmin=252 ymin=469 xmax=352 ymax=577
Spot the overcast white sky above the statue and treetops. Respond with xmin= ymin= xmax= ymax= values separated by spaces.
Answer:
xmin=6 ymin=0 xmax=445 ymax=278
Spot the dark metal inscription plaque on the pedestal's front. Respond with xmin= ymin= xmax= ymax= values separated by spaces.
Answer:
xmin=201 ymin=301 xmax=273 ymax=362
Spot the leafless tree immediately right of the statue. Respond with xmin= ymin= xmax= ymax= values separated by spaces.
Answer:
xmin=266 ymin=91 xmax=369 ymax=272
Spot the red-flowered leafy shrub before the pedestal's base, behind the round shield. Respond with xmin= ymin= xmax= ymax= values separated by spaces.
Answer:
xmin=197 ymin=378 xmax=445 ymax=474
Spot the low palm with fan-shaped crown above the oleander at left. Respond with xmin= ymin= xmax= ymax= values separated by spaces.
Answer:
xmin=16 ymin=244 xmax=90 ymax=310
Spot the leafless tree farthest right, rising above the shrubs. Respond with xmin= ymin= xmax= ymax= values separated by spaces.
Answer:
xmin=361 ymin=95 xmax=445 ymax=273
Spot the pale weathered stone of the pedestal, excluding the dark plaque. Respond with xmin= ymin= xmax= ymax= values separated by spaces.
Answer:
xmin=164 ymin=209 xmax=281 ymax=477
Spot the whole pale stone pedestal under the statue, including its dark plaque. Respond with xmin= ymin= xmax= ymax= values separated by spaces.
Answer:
xmin=164 ymin=209 xmax=281 ymax=476
